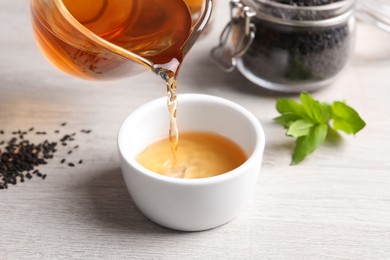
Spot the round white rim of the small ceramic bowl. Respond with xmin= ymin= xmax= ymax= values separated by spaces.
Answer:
xmin=117 ymin=93 xmax=265 ymax=186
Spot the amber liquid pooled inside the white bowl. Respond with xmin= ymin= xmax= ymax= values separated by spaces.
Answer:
xmin=136 ymin=132 xmax=247 ymax=179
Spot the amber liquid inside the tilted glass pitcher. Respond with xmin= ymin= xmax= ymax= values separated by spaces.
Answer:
xmin=32 ymin=0 xmax=195 ymax=80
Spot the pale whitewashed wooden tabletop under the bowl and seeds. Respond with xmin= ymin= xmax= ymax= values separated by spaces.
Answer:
xmin=0 ymin=0 xmax=390 ymax=259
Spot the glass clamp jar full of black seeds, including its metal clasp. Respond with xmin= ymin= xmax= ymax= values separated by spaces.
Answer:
xmin=211 ymin=0 xmax=355 ymax=92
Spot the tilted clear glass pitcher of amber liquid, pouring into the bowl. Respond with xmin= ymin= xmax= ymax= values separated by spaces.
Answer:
xmin=31 ymin=0 xmax=212 ymax=80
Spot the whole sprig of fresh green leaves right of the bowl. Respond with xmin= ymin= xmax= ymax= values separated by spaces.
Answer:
xmin=274 ymin=92 xmax=366 ymax=165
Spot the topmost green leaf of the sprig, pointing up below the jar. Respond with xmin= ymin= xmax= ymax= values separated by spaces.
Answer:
xmin=299 ymin=92 xmax=330 ymax=124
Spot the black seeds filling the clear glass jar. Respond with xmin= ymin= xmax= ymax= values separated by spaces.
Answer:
xmin=242 ymin=4 xmax=351 ymax=85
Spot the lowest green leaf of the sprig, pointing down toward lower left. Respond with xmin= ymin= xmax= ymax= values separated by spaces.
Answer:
xmin=291 ymin=124 xmax=328 ymax=165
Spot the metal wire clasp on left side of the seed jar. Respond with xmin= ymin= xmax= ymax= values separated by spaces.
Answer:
xmin=211 ymin=0 xmax=256 ymax=72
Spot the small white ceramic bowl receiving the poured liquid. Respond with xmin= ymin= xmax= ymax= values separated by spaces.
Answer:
xmin=118 ymin=94 xmax=265 ymax=231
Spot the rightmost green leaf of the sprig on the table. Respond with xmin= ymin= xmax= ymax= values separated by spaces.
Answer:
xmin=332 ymin=101 xmax=366 ymax=134
